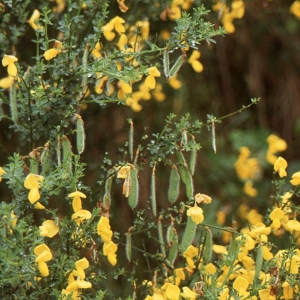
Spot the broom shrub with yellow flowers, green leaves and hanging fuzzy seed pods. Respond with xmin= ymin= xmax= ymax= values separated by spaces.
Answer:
xmin=0 ymin=0 xmax=300 ymax=300
